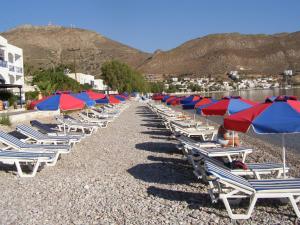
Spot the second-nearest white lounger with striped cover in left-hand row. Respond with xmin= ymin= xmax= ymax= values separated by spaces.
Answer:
xmin=0 ymin=131 xmax=71 ymax=154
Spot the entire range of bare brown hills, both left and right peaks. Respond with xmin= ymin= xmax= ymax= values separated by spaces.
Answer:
xmin=0 ymin=25 xmax=300 ymax=76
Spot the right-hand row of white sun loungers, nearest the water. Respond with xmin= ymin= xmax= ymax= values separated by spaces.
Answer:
xmin=148 ymin=102 xmax=300 ymax=220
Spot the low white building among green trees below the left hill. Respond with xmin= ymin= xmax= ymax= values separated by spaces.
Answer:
xmin=66 ymin=73 xmax=107 ymax=91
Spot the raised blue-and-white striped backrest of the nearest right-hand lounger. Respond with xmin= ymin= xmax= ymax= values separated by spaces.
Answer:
xmin=205 ymin=161 xmax=255 ymax=191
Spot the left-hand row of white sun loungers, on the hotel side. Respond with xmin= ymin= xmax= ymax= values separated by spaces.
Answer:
xmin=0 ymin=104 xmax=127 ymax=177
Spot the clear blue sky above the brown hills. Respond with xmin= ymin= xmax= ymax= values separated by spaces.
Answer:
xmin=0 ymin=0 xmax=300 ymax=52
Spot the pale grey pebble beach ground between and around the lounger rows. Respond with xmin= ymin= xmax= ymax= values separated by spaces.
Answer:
xmin=0 ymin=102 xmax=299 ymax=225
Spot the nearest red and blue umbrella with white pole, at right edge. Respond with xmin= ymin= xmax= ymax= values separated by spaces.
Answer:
xmin=224 ymin=96 xmax=300 ymax=176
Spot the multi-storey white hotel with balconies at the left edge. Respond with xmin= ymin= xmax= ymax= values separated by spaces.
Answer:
xmin=0 ymin=36 xmax=24 ymax=99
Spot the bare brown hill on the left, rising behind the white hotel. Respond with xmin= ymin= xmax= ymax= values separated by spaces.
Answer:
xmin=0 ymin=25 xmax=149 ymax=75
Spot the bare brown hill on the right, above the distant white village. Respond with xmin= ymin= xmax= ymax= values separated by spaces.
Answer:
xmin=139 ymin=32 xmax=300 ymax=75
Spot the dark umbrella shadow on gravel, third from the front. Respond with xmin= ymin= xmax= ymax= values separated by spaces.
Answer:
xmin=135 ymin=142 xmax=181 ymax=154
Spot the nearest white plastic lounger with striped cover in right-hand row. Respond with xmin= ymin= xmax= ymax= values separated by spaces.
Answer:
xmin=205 ymin=161 xmax=300 ymax=219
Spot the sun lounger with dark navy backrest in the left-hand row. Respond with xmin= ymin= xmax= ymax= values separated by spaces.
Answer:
xmin=30 ymin=120 xmax=85 ymax=139
